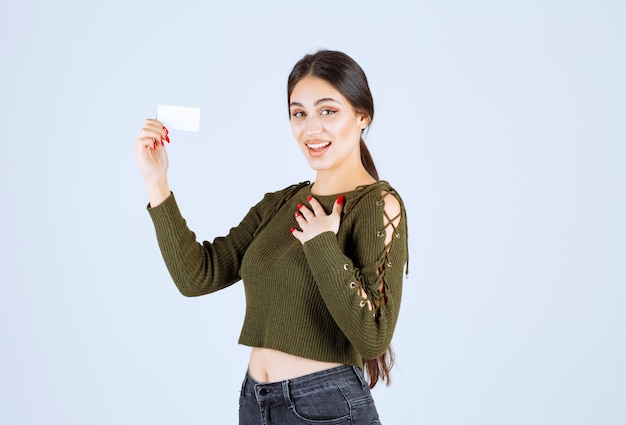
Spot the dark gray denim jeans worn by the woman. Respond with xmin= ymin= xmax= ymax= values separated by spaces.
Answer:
xmin=239 ymin=366 xmax=380 ymax=425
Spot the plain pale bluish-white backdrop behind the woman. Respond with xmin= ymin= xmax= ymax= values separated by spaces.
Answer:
xmin=0 ymin=0 xmax=626 ymax=425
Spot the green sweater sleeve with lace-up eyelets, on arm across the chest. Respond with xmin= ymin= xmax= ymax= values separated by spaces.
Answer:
xmin=304 ymin=189 xmax=408 ymax=360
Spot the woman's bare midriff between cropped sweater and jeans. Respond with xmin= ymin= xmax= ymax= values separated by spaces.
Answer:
xmin=248 ymin=347 xmax=341 ymax=382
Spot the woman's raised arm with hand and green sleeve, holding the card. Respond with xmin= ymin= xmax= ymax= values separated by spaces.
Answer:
xmin=135 ymin=118 xmax=305 ymax=296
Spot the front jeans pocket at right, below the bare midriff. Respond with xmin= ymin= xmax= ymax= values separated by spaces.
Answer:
xmin=292 ymin=387 xmax=350 ymax=425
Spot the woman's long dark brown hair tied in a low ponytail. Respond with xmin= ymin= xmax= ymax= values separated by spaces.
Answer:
xmin=287 ymin=50 xmax=394 ymax=388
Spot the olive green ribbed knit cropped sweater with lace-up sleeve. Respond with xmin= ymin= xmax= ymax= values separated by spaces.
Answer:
xmin=148 ymin=181 xmax=408 ymax=367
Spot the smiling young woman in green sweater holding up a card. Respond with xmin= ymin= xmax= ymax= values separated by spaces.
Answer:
xmin=135 ymin=51 xmax=408 ymax=425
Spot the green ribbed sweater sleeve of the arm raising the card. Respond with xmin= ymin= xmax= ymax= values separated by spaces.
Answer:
xmin=148 ymin=192 xmax=288 ymax=297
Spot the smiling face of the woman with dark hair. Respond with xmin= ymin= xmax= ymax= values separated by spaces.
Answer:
xmin=289 ymin=77 xmax=369 ymax=171
